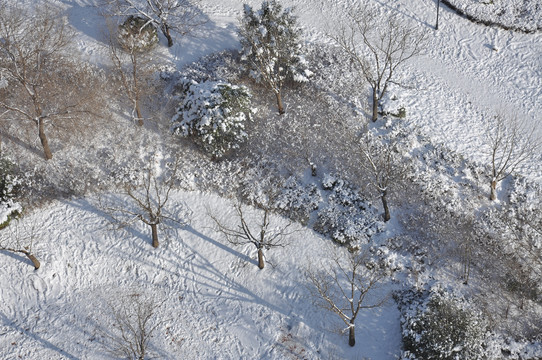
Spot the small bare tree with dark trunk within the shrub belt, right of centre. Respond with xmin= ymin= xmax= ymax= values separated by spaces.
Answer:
xmin=360 ymin=129 xmax=407 ymax=221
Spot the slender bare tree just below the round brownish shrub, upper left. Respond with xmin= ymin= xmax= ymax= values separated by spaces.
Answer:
xmin=108 ymin=18 xmax=154 ymax=126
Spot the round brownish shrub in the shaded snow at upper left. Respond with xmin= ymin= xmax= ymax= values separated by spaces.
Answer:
xmin=118 ymin=16 xmax=158 ymax=51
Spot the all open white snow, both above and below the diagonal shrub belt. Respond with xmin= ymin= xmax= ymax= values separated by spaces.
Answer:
xmin=0 ymin=0 xmax=542 ymax=360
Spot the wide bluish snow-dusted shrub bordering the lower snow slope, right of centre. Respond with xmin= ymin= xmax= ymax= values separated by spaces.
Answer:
xmin=314 ymin=175 xmax=383 ymax=246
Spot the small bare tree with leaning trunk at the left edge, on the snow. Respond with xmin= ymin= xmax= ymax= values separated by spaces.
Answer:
xmin=0 ymin=219 xmax=40 ymax=270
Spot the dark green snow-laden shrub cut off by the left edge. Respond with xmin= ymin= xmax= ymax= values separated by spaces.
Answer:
xmin=0 ymin=158 xmax=22 ymax=229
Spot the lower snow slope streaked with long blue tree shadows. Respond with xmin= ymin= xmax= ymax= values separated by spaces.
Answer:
xmin=0 ymin=192 xmax=401 ymax=359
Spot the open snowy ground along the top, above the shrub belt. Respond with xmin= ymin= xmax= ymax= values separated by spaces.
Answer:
xmin=64 ymin=0 xmax=542 ymax=179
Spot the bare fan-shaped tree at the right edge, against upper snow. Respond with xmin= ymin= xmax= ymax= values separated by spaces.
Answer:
xmin=486 ymin=114 xmax=541 ymax=200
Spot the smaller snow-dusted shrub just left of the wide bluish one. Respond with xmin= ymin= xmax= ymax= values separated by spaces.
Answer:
xmin=274 ymin=177 xmax=322 ymax=225
